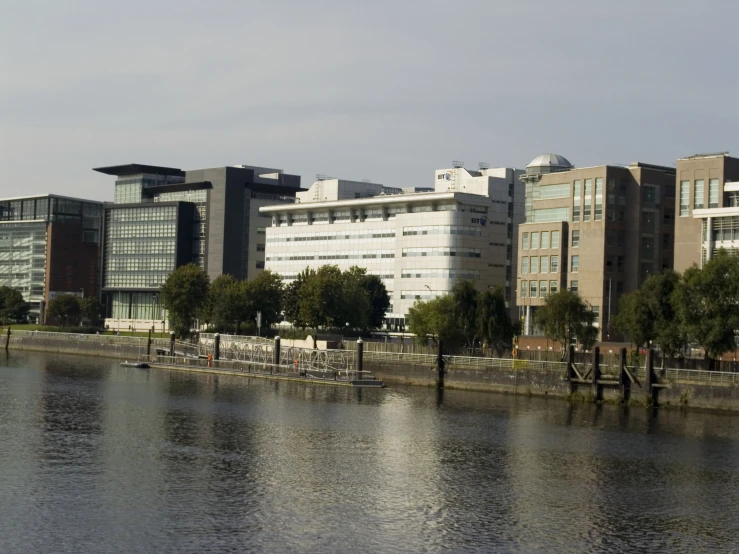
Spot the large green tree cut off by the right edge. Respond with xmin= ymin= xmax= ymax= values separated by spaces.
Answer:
xmin=674 ymin=249 xmax=739 ymax=360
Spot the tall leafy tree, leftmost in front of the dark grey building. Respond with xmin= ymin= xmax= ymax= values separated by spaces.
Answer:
xmin=161 ymin=263 xmax=210 ymax=338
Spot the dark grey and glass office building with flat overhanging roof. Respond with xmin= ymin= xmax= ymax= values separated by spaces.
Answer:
xmin=95 ymin=164 xmax=300 ymax=329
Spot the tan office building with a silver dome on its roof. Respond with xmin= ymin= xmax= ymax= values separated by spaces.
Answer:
xmin=517 ymin=154 xmax=675 ymax=340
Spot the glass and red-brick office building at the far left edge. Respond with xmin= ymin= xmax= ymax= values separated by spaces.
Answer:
xmin=0 ymin=194 xmax=103 ymax=322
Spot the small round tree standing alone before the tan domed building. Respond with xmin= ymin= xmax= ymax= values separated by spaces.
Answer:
xmin=535 ymin=289 xmax=598 ymax=353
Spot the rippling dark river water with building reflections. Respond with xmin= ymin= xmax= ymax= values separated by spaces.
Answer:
xmin=0 ymin=351 xmax=739 ymax=553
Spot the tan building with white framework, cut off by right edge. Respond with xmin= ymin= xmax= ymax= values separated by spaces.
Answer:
xmin=675 ymin=152 xmax=739 ymax=272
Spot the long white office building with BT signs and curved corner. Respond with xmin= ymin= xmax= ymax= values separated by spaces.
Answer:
xmin=260 ymin=167 xmax=524 ymax=329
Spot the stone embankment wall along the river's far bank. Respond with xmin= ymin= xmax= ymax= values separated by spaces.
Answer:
xmin=5 ymin=331 xmax=739 ymax=413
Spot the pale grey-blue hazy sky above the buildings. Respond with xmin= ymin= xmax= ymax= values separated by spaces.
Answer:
xmin=0 ymin=0 xmax=739 ymax=200
